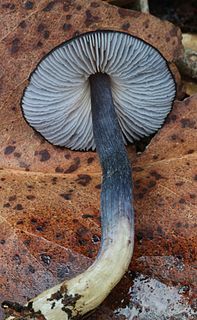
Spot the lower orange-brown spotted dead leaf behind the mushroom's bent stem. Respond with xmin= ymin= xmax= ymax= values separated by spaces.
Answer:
xmin=0 ymin=95 xmax=197 ymax=319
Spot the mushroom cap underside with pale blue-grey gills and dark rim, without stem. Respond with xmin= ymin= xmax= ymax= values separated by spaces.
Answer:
xmin=22 ymin=30 xmax=176 ymax=150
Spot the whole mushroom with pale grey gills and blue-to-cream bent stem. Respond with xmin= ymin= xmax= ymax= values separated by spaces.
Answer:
xmin=3 ymin=30 xmax=176 ymax=320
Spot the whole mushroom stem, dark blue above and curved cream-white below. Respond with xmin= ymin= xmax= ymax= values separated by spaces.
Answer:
xmin=4 ymin=73 xmax=134 ymax=320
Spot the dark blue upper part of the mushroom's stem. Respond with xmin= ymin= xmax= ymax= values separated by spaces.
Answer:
xmin=89 ymin=73 xmax=133 ymax=242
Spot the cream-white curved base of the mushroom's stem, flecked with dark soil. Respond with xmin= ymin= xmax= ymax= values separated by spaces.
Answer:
xmin=7 ymin=217 xmax=134 ymax=320
